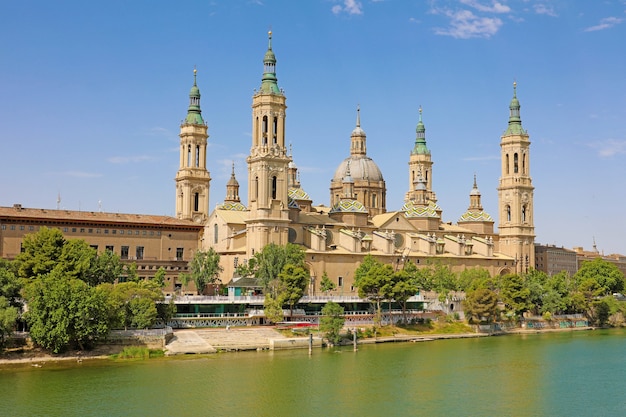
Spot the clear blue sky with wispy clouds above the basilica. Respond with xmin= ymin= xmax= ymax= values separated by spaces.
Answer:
xmin=0 ymin=0 xmax=626 ymax=254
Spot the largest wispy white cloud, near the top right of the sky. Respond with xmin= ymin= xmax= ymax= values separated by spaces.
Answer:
xmin=435 ymin=10 xmax=502 ymax=39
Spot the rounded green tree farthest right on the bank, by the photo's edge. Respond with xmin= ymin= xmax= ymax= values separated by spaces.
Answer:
xmin=574 ymin=258 xmax=624 ymax=296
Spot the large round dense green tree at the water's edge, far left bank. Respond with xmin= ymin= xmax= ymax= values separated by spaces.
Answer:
xmin=24 ymin=271 xmax=109 ymax=353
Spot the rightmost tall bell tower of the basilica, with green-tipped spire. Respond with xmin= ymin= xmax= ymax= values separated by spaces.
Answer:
xmin=498 ymin=83 xmax=535 ymax=273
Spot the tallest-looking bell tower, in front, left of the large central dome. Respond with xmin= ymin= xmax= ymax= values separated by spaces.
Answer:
xmin=246 ymin=32 xmax=291 ymax=256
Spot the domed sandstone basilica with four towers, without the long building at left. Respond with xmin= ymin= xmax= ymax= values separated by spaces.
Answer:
xmin=176 ymin=32 xmax=535 ymax=295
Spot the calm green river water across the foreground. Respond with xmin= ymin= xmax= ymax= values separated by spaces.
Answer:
xmin=0 ymin=330 xmax=626 ymax=417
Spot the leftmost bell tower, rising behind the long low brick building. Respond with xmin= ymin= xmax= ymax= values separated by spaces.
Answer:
xmin=176 ymin=69 xmax=211 ymax=223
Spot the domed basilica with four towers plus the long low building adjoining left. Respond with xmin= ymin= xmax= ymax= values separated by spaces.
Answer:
xmin=0 ymin=32 xmax=535 ymax=296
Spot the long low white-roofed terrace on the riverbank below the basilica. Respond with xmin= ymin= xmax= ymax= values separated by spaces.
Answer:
xmin=163 ymin=292 xmax=465 ymax=328
